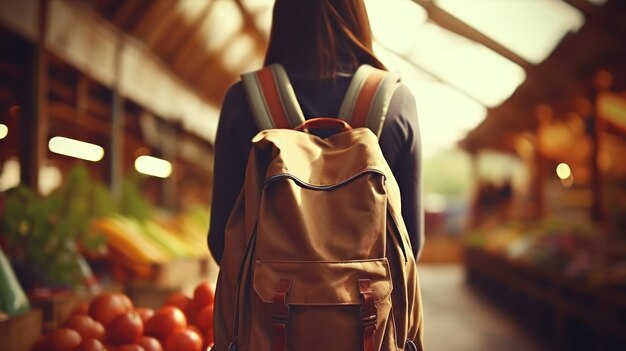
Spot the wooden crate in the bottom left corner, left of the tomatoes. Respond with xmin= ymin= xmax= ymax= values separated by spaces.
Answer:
xmin=0 ymin=309 xmax=42 ymax=351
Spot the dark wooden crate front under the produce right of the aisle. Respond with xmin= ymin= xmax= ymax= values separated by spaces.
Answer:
xmin=465 ymin=248 xmax=626 ymax=351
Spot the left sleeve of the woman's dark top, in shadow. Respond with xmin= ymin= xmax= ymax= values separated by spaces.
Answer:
xmin=208 ymin=83 xmax=256 ymax=264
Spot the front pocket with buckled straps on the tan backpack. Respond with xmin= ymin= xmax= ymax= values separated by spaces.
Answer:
xmin=250 ymin=258 xmax=393 ymax=351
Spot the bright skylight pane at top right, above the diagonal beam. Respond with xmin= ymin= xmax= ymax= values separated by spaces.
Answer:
xmin=435 ymin=0 xmax=584 ymax=64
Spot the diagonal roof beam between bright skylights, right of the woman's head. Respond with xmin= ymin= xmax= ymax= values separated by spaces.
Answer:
xmin=413 ymin=0 xmax=532 ymax=70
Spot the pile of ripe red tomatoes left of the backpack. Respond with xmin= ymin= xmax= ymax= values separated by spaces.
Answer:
xmin=31 ymin=282 xmax=215 ymax=351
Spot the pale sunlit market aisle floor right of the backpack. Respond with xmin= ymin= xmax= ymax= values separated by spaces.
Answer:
xmin=420 ymin=264 xmax=546 ymax=351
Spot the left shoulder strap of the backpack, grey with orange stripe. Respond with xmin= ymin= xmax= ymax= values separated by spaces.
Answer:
xmin=241 ymin=64 xmax=304 ymax=130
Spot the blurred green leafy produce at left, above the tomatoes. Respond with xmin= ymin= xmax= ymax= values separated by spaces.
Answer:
xmin=0 ymin=166 xmax=116 ymax=289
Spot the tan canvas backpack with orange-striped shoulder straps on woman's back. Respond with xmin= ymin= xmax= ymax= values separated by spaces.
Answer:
xmin=214 ymin=65 xmax=423 ymax=351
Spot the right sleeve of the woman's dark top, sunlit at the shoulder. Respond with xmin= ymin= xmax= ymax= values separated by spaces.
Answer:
xmin=380 ymin=85 xmax=424 ymax=260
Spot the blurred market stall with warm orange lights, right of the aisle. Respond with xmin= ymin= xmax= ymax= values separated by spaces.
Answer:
xmin=461 ymin=3 xmax=626 ymax=350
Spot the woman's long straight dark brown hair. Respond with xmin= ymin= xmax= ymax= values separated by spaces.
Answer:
xmin=265 ymin=0 xmax=386 ymax=80
